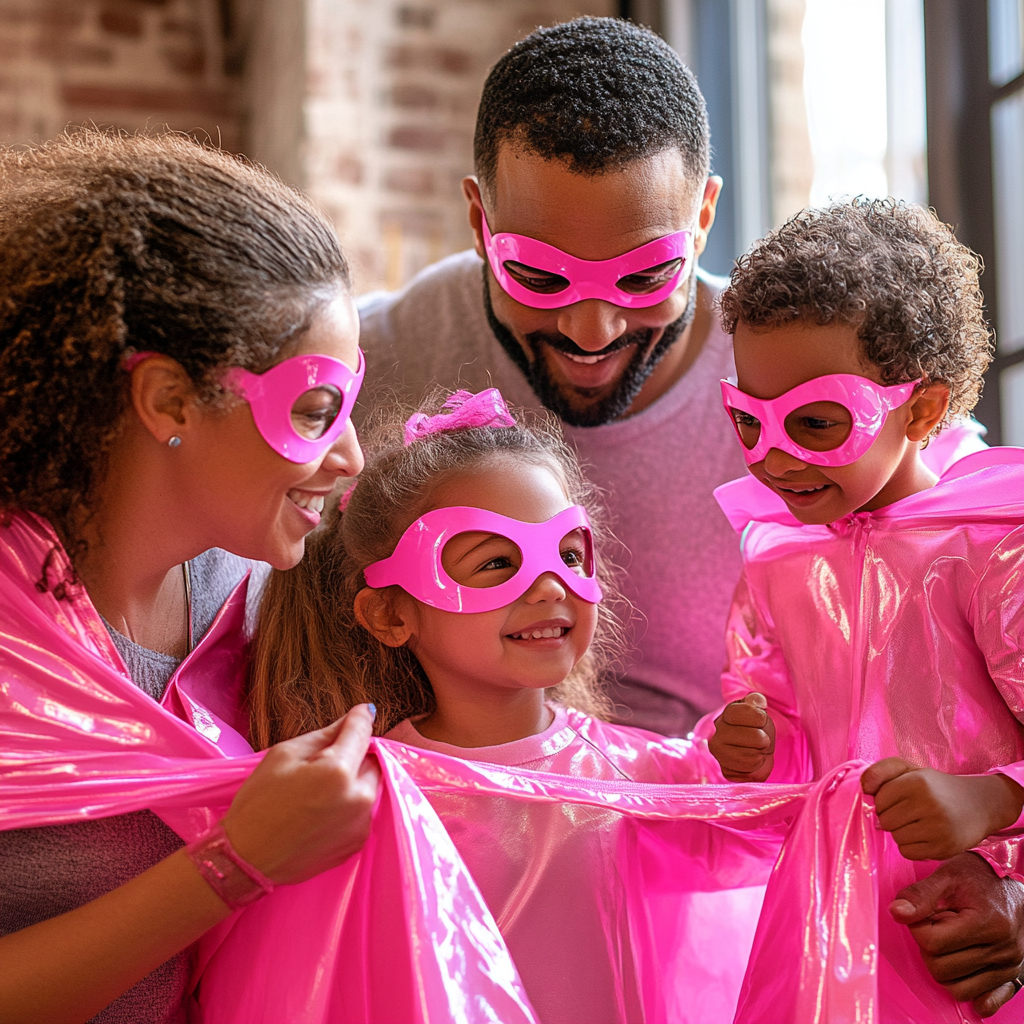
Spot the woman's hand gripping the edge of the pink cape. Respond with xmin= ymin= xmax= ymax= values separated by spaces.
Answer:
xmin=224 ymin=705 xmax=380 ymax=885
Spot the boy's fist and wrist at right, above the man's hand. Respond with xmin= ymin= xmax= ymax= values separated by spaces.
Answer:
xmin=860 ymin=758 xmax=1024 ymax=860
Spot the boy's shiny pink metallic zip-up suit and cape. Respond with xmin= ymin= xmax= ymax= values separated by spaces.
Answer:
xmin=712 ymin=447 xmax=1024 ymax=1022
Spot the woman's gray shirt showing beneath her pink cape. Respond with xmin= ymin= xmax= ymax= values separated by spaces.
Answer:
xmin=0 ymin=548 xmax=269 ymax=1024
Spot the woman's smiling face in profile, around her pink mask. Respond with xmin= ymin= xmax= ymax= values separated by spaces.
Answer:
xmin=184 ymin=294 xmax=362 ymax=569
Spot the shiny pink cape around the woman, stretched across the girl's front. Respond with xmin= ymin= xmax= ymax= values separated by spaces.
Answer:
xmin=0 ymin=515 xmax=961 ymax=1024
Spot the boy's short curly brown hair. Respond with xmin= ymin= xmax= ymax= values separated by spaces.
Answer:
xmin=719 ymin=198 xmax=992 ymax=420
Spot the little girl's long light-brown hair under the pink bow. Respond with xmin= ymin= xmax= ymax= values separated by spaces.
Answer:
xmin=249 ymin=398 xmax=623 ymax=749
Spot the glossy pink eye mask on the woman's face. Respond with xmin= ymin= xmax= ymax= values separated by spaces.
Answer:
xmin=222 ymin=349 xmax=367 ymax=463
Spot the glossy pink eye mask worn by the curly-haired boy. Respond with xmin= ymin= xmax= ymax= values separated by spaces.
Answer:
xmin=722 ymin=374 xmax=921 ymax=466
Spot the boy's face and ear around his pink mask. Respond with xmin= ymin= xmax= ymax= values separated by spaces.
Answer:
xmin=733 ymin=321 xmax=948 ymax=523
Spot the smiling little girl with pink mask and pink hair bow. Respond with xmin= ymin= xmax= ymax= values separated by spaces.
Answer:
xmin=250 ymin=390 xmax=761 ymax=1021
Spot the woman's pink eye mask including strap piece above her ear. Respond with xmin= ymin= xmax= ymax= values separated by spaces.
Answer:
xmin=121 ymin=349 xmax=367 ymax=463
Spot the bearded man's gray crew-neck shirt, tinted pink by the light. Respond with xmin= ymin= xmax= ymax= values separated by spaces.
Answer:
xmin=358 ymin=252 xmax=745 ymax=735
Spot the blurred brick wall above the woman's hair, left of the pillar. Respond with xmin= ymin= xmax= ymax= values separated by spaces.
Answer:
xmin=0 ymin=0 xmax=242 ymax=150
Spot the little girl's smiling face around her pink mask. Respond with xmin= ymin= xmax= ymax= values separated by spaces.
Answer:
xmin=396 ymin=459 xmax=597 ymax=696
